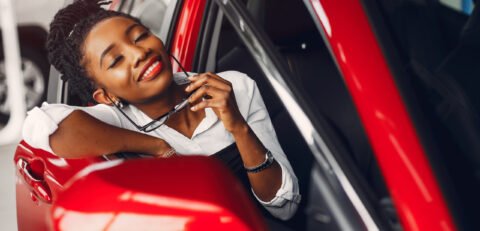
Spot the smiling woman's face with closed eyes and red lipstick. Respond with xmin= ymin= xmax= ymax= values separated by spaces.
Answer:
xmin=83 ymin=17 xmax=173 ymax=104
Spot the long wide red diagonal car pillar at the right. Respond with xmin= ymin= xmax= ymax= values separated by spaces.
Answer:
xmin=310 ymin=0 xmax=455 ymax=230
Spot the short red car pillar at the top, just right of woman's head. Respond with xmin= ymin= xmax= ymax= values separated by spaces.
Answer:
xmin=170 ymin=0 xmax=206 ymax=72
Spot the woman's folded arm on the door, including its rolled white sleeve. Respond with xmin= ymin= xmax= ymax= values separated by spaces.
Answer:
xmin=23 ymin=103 xmax=170 ymax=158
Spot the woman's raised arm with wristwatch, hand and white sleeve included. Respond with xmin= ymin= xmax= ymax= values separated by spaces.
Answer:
xmin=187 ymin=71 xmax=301 ymax=220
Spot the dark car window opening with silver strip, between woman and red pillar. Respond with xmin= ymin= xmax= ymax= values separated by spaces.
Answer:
xmin=193 ymin=0 xmax=399 ymax=230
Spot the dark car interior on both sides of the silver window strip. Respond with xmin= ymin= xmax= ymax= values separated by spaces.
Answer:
xmin=209 ymin=0 xmax=398 ymax=230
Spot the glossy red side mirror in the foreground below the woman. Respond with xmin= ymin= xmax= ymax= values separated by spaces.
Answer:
xmin=50 ymin=157 xmax=266 ymax=230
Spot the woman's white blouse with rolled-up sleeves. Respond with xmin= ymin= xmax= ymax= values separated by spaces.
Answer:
xmin=23 ymin=71 xmax=301 ymax=220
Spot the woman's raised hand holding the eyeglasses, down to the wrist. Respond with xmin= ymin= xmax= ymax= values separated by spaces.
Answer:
xmin=185 ymin=72 xmax=247 ymax=133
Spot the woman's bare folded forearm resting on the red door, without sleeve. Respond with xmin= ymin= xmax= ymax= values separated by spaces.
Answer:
xmin=49 ymin=110 xmax=170 ymax=158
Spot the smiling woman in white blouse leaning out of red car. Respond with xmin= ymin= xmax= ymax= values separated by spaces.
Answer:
xmin=24 ymin=0 xmax=300 ymax=220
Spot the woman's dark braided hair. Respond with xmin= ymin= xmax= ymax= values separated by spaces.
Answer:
xmin=47 ymin=0 xmax=141 ymax=105
